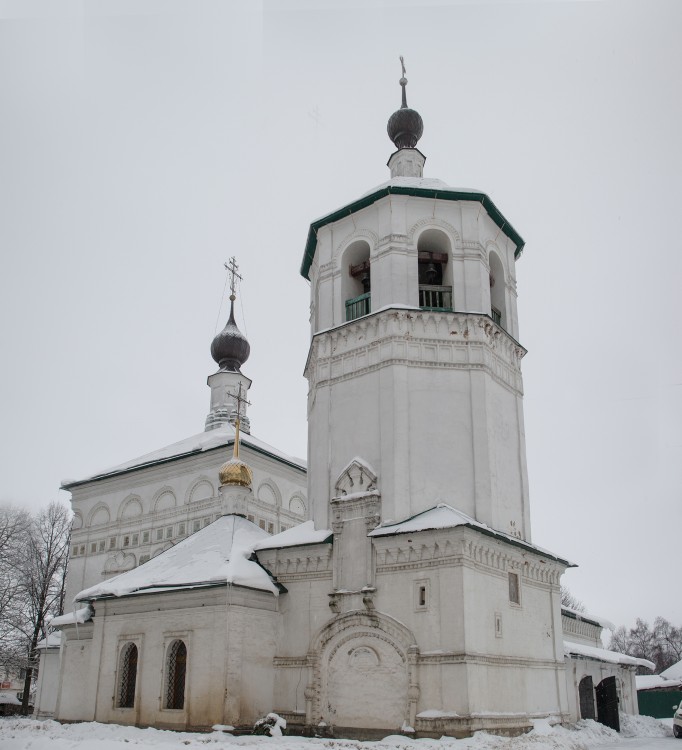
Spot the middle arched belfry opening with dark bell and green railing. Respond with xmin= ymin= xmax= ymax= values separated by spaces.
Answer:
xmin=417 ymin=229 xmax=453 ymax=311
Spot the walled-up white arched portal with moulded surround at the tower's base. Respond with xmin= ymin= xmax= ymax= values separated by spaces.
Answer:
xmin=306 ymin=611 xmax=419 ymax=731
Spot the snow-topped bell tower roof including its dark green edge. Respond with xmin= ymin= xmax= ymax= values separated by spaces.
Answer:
xmin=301 ymin=177 xmax=525 ymax=279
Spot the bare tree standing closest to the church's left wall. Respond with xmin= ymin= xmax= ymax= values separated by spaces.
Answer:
xmin=17 ymin=502 xmax=71 ymax=714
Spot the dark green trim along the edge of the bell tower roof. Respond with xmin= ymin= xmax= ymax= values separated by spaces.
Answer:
xmin=301 ymin=185 xmax=526 ymax=281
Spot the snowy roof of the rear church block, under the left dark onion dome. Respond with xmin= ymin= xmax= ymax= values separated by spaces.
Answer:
xmin=62 ymin=424 xmax=306 ymax=490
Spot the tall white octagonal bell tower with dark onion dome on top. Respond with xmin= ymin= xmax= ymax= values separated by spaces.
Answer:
xmin=301 ymin=58 xmax=531 ymax=541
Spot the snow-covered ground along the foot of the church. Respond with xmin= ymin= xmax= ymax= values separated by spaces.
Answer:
xmin=0 ymin=715 xmax=682 ymax=750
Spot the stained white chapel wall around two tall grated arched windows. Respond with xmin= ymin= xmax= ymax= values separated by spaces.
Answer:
xmin=58 ymin=586 xmax=278 ymax=729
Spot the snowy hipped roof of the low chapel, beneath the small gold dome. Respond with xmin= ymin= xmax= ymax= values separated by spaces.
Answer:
xmin=76 ymin=515 xmax=279 ymax=604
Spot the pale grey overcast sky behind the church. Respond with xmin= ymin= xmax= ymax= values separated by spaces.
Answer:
xmin=0 ymin=0 xmax=682 ymax=626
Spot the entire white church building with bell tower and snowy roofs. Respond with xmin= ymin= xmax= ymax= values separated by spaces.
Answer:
xmin=42 ymin=67 xmax=639 ymax=736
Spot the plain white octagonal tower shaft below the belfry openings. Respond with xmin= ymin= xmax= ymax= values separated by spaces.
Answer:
xmin=307 ymin=310 xmax=530 ymax=540
